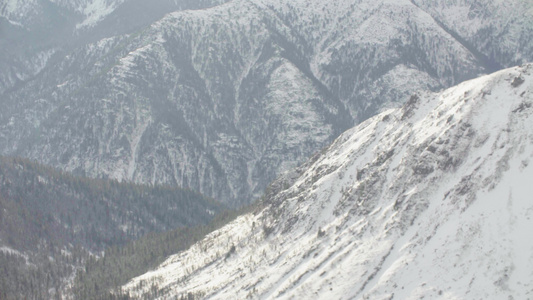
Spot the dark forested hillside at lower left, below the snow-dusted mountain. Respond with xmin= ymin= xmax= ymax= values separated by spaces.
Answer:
xmin=0 ymin=157 xmax=224 ymax=299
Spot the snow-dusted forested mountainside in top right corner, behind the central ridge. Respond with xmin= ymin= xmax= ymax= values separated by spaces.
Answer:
xmin=412 ymin=0 xmax=533 ymax=68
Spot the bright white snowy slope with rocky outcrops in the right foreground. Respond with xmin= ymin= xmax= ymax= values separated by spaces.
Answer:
xmin=123 ymin=64 xmax=533 ymax=299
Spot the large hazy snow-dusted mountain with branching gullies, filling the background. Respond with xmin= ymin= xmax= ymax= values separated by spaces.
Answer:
xmin=0 ymin=0 xmax=533 ymax=205
